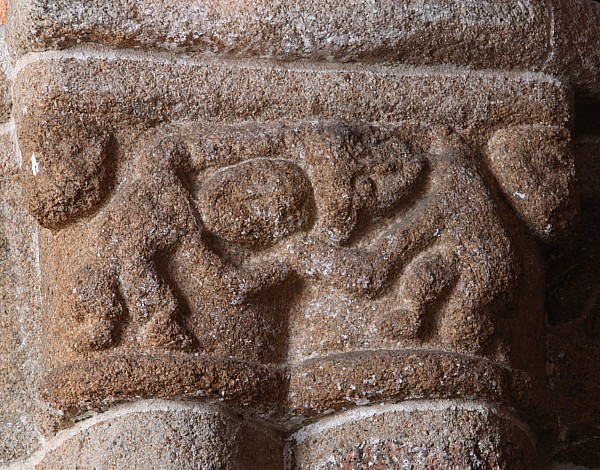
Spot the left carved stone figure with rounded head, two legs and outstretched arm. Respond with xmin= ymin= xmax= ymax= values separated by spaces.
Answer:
xmin=62 ymin=134 xmax=303 ymax=358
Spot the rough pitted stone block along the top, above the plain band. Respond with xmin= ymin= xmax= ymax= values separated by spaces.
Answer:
xmin=9 ymin=0 xmax=550 ymax=69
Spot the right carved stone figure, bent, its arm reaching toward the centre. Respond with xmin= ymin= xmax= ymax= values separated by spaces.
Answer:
xmin=293 ymin=128 xmax=519 ymax=353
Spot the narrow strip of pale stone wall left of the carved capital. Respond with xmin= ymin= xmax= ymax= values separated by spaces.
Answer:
xmin=0 ymin=134 xmax=39 ymax=466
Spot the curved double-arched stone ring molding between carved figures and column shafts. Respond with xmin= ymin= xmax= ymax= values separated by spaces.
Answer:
xmin=41 ymin=350 xmax=553 ymax=428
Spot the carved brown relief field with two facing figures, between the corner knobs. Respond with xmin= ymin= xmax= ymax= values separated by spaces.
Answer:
xmin=33 ymin=121 xmax=556 ymax=408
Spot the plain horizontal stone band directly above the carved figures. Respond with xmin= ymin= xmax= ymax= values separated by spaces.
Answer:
xmin=14 ymin=55 xmax=573 ymax=143
